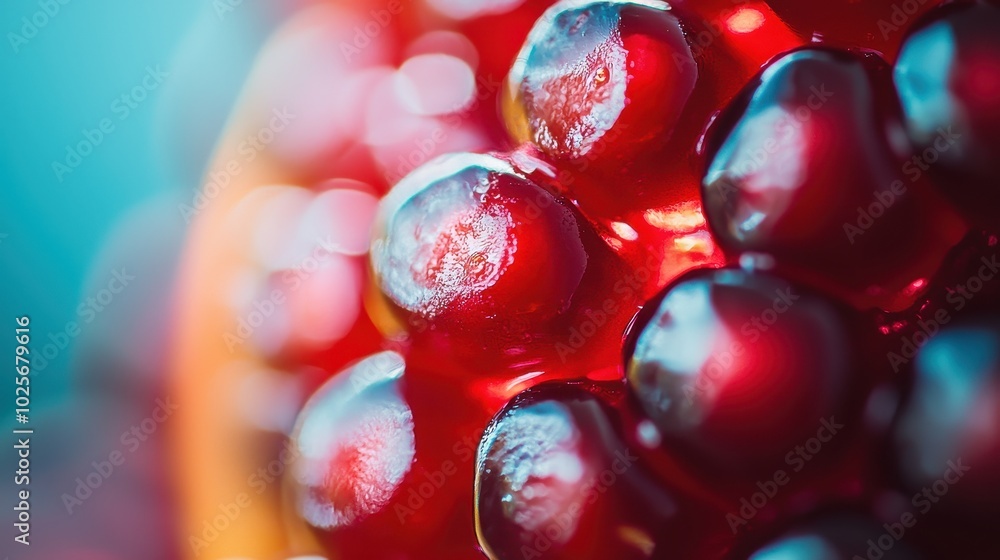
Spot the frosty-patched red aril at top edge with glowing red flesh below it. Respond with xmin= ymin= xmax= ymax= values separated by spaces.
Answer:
xmin=504 ymin=1 xmax=792 ymax=297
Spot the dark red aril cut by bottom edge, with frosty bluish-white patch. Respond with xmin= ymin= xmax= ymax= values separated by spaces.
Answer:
xmin=476 ymin=383 xmax=723 ymax=560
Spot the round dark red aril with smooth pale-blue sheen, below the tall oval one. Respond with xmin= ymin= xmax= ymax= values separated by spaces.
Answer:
xmin=627 ymin=269 xmax=865 ymax=480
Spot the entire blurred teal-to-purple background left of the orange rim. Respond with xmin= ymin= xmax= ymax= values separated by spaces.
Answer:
xmin=0 ymin=0 xmax=290 ymax=560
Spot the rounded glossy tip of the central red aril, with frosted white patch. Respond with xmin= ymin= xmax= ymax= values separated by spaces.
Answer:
xmin=372 ymin=155 xmax=588 ymax=322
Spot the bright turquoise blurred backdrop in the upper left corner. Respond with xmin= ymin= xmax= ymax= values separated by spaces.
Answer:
xmin=0 ymin=0 xmax=274 ymax=402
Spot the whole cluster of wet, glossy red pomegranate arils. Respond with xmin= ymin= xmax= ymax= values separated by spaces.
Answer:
xmin=176 ymin=0 xmax=1000 ymax=560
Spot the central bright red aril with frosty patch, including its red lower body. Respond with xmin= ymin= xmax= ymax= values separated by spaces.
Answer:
xmin=371 ymin=154 xmax=638 ymax=378
